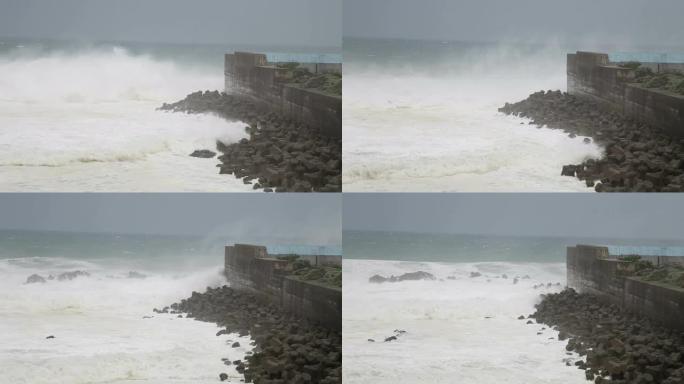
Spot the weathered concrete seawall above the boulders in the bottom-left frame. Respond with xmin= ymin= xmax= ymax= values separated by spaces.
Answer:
xmin=225 ymin=244 xmax=342 ymax=331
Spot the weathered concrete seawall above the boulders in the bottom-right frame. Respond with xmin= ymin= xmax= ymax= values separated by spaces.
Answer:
xmin=566 ymin=245 xmax=684 ymax=330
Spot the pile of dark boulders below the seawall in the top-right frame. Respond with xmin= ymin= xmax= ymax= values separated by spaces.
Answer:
xmin=499 ymin=91 xmax=684 ymax=192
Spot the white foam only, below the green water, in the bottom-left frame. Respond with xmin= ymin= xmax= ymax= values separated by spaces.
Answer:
xmin=0 ymin=257 xmax=251 ymax=384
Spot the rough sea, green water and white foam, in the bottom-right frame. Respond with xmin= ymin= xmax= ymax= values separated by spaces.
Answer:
xmin=343 ymin=232 xmax=684 ymax=384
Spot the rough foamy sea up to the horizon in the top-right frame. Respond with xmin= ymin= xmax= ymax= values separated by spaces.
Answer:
xmin=343 ymin=39 xmax=602 ymax=192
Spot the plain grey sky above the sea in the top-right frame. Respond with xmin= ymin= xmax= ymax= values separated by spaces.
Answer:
xmin=343 ymin=0 xmax=684 ymax=47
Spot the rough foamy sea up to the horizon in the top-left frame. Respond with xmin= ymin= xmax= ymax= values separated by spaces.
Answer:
xmin=0 ymin=38 xmax=336 ymax=192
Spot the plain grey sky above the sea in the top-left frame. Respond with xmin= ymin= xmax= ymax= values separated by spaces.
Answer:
xmin=0 ymin=0 xmax=342 ymax=47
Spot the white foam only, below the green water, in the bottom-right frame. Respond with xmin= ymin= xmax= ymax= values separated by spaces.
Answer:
xmin=342 ymin=259 xmax=585 ymax=384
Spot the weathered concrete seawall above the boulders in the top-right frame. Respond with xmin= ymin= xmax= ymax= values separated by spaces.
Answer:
xmin=567 ymin=52 xmax=684 ymax=137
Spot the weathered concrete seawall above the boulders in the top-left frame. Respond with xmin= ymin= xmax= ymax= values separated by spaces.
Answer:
xmin=224 ymin=52 xmax=342 ymax=137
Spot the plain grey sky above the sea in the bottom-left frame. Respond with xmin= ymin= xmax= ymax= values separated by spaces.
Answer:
xmin=0 ymin=193 xmax=342 ymax=245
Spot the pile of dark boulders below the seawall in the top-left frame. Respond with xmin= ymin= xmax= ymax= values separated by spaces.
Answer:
xmin=159 ymin=91 xmax=342 ymax=192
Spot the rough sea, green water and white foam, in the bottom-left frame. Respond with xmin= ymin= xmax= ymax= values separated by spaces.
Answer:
xmin=0 ymin=231 xmax=340 ymax=384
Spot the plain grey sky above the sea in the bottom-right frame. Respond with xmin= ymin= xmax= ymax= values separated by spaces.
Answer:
xmin=343 ymin=193 xmax=684 ymax=240
